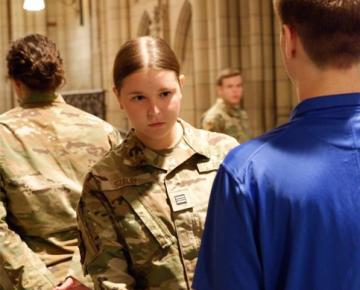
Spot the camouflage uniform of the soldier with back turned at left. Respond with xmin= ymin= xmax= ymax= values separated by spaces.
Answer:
xmin=0 ymin=95 xmax=120 ymax=289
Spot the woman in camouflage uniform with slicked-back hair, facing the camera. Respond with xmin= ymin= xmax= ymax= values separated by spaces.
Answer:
xmin=78 ymin=37 xmax=238 ymax=290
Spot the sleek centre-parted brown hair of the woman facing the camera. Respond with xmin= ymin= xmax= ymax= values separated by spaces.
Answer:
xmin=113 ymin=36 xmax=180 ymax=89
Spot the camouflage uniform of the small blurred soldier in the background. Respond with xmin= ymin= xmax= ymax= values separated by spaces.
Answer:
xmin=201 ymin=98 xmax=252 ymax=143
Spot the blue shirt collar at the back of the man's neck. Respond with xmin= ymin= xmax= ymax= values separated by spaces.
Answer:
xmin=290 ymin=92 xmax=360 ymax=120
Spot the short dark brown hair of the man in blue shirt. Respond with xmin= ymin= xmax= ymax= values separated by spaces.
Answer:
xmin=274 ymin=0 xmax=360 ymax=68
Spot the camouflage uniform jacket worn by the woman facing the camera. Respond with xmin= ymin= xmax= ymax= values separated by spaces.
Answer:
xmin=78 ymin=120 xmax=238 ymax=290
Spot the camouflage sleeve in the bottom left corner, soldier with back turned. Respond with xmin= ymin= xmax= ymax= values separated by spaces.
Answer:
xmin=0 ymin=176 xmax=56 ymax=290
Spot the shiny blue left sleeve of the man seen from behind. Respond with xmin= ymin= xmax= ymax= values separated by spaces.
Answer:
xmin=193 ymin=165 xmax=263 ymax=290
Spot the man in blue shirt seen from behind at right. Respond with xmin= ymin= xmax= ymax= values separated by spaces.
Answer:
xmin=193 ymin=0 xmax=360 ymax=290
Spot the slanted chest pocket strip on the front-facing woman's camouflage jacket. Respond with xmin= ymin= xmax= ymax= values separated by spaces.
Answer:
xmin=123 ymin=192 xmax=176 ymax=249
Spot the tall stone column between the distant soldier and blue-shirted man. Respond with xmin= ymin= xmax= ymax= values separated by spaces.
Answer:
xmin=240 ymin=0 xmax=281 ymax=134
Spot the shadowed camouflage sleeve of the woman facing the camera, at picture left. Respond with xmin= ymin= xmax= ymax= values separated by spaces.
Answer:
xmin=77 ymin=174 xmax=134 ymax=290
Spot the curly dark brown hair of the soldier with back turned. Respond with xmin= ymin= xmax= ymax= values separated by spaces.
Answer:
xmin=6 ymin=34 xmax=64 ymax=91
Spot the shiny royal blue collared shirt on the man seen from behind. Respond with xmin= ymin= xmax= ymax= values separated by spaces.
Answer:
xmin=193 ymin=94 xmax=360 ymax=290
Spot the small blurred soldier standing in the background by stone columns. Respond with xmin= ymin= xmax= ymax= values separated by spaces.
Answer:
xmin=201 ymin=69 xmax=252 ymax=143
